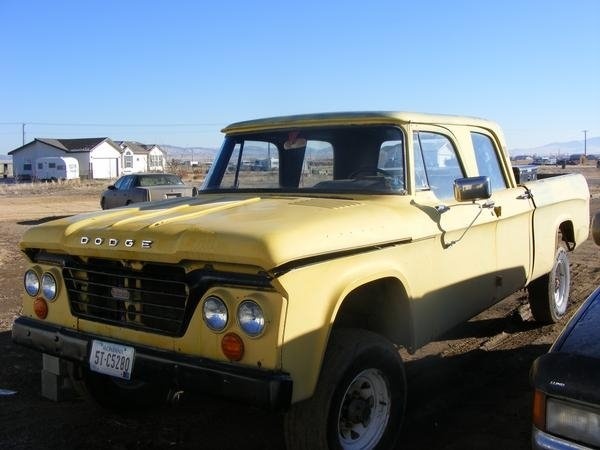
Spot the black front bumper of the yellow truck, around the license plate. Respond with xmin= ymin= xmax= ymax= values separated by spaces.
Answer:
xmin=12 ymin=317 xmax=292 ymax=410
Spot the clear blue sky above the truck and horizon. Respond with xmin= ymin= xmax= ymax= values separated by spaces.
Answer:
xmin=0 ymin=0 xmax=600 ymax=154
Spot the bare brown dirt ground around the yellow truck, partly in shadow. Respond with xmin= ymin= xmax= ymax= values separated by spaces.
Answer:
xmin=0 ymin=167 xmax=600 ymax=450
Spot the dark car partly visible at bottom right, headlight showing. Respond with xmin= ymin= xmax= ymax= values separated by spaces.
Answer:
xmin=531 ymin=213 xmax=600 ymax=450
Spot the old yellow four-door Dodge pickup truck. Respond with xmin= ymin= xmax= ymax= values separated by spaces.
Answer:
xmin=13 ymin=112 xmax=589 ymax=449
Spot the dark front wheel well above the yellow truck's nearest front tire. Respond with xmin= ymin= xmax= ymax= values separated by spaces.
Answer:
xmin=333 ymin=278 xmax=412 ymax=349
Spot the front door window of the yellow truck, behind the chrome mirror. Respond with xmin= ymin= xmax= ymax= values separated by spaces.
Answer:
xmin=413 ymin=131 xmax=464 ymax=199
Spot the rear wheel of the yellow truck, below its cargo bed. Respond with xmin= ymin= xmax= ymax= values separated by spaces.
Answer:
xmin=527 ymin=239 xmax=571 ymax=324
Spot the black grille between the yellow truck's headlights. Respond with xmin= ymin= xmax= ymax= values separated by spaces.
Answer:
xmin=63 ymin=260 xmax=189 ymax=336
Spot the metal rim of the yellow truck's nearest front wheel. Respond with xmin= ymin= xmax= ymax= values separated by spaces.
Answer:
xmin=337 ymin=369 xmax=392 ymax=450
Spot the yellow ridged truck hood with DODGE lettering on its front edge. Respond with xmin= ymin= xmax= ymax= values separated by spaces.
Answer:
xmin=21 ymin=194 xmax=410 ymax=270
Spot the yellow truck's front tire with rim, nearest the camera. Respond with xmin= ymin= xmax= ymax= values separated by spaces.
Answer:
xmin=285 ymin=330 xmax=406 ymax=450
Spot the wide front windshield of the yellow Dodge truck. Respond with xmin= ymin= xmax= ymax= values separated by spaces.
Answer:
xmin=203 ymin=125 xmax=405 ymax=194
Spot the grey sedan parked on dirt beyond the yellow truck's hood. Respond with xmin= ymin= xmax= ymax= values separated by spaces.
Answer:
xmin=100 ymin=173 xmax=198 ymax=209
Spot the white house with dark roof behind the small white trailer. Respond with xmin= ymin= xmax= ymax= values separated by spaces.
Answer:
xmin=8 ymin=138 xmax=166 ymax=180
